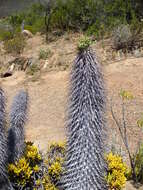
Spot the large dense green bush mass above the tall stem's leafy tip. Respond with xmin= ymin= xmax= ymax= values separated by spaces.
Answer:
xmin=47 ymin=0 xmax=140 ymax=37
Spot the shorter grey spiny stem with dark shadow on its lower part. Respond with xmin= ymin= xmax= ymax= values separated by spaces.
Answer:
xmin=8 ymin=90 xmax=28 ymax=163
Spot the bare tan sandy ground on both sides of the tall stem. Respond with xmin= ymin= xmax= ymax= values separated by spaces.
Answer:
xmin=0 ymin=32 xmax=143 ymax=190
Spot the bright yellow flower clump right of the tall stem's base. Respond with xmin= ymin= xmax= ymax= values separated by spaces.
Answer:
xmin=106 ymin=152 xmax=128 ymax=190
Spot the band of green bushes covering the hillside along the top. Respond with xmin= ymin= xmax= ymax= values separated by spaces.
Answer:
xmin=0 ymin=0 xmax=143 ymax=39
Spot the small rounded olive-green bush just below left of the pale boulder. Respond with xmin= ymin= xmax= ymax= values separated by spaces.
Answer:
xmin=4 ymin=34 xmax=26 ymax=54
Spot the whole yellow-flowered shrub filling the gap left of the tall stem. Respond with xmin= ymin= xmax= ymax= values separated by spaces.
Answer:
xmin=8 ymin=142 xmax=65 ymax=190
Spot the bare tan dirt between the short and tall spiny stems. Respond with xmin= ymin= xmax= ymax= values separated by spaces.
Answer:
xmin=2 ymin=72 xmax=68 ymax=149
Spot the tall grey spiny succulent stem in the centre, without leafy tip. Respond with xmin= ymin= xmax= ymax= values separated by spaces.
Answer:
xmin=59 ymin=48 xmax=107 ymax=190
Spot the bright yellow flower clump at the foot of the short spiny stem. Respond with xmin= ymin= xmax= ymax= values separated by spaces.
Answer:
xmin=8 ymin=142 xmax=42 ymax=189
